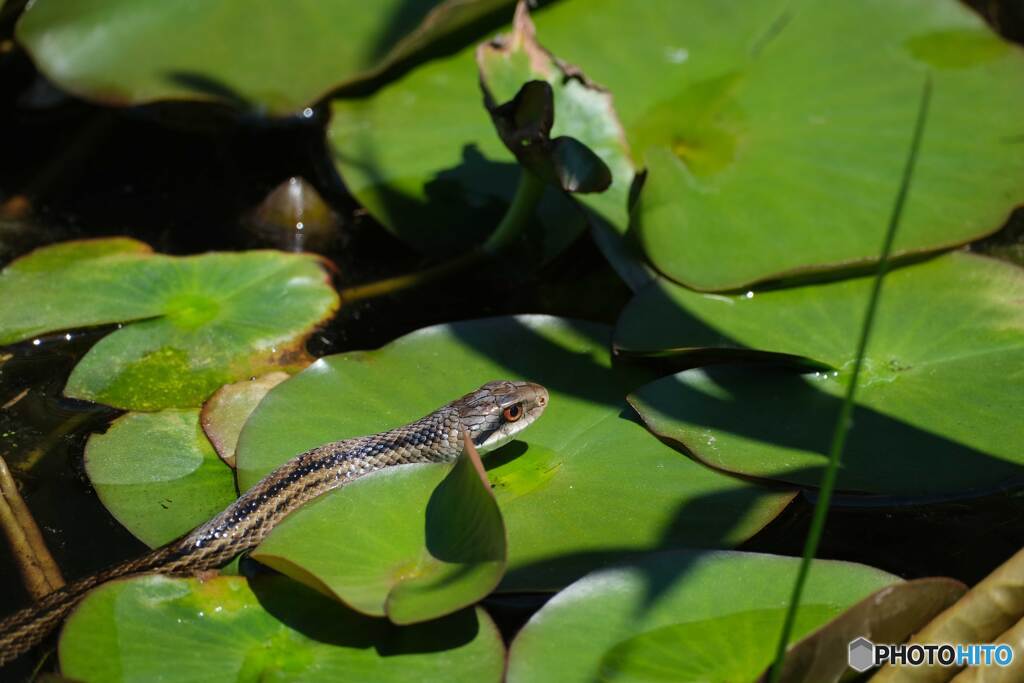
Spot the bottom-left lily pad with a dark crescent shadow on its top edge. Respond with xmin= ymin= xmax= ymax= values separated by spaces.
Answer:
xmin=59 ymin=574 xmax=504 ymax=683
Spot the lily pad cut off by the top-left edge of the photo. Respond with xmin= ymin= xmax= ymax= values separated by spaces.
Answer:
xmin=17 ymin=0 xmax=520 ymax=116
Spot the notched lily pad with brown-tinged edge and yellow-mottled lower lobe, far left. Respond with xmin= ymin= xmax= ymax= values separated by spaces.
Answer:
xmin=0 ymin=238 xmax=338 ymax=411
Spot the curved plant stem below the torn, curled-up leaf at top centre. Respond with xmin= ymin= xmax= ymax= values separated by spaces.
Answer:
xmin=340 ymin=169 xmax=544 ymax=302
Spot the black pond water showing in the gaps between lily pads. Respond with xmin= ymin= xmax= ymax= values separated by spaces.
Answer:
xmin=0 ymin=1 xmax=1024 ymax=680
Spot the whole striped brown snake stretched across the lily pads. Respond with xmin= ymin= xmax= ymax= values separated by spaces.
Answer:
xmin=0 ymin=380 xmax=548 ymax=666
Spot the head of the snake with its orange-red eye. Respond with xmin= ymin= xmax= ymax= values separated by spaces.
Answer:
xmin=452 ymin=380 xmax=548 ymax=453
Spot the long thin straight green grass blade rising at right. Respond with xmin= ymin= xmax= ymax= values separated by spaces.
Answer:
xmin=769 ymin=75 xmax=932 ymax=683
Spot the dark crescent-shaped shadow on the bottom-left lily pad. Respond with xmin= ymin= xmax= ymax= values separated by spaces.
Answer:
xmin=249 ymin=573 xmax=480 ymax=656
